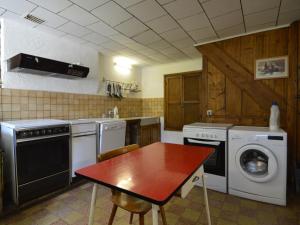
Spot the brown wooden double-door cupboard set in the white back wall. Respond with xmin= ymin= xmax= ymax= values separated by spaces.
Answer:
xmin=164 ymin=71 xmax=202 ymax=130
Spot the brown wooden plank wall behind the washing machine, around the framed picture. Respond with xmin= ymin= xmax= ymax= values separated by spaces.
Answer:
xmin=198 ymin=22 xmax=300 ymax=176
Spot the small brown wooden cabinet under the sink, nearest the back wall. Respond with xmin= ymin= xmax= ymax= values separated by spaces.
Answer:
xmin=139 ymin=123 xmax=160 ymax=147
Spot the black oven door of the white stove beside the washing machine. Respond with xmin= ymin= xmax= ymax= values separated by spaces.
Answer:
xmin=184 ymin=138 xmax=225 ymax=176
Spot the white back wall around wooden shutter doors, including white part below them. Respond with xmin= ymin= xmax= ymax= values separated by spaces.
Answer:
xmin=142 ymin=58 xmax=202 ymax=144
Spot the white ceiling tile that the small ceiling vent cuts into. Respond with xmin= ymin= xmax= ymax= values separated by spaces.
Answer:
xmin=30 ymin=7 xmax=67 ymax=28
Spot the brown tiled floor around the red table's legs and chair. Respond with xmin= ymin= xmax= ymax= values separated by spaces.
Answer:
xmin=0 ymin=184 xmax=300 ymax=225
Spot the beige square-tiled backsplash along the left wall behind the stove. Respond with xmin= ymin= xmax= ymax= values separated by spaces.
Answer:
xmin=0 ymin=88 xmax=143 ymax=121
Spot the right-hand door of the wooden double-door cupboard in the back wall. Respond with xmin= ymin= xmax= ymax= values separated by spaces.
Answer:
xmin=182 ymin=71 xmax=202 ymax=125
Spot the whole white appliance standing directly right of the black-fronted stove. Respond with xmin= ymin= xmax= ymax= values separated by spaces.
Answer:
xmin=70 ymin=120 xmax=97 ymax=179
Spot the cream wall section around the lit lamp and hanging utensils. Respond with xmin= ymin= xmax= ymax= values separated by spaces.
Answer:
xmin=99 ymin=54 xmax=142 ymax=98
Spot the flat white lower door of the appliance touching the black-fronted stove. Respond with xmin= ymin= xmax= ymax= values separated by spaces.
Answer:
xmin=72 ymin=133 xmax=97 ymax=177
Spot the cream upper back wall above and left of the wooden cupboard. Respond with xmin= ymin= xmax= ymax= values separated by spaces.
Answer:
xmin=142 ymin=58 xmax=202 ymax=98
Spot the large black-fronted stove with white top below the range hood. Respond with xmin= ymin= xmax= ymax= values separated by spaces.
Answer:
xmin=0 ymin=119 xmax=70 ymax=205
